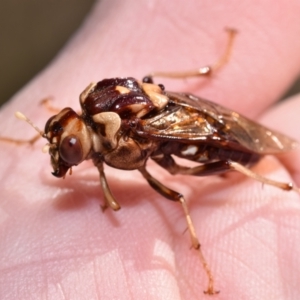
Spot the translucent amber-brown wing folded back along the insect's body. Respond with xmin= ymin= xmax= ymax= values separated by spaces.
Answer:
xmin=140 ymin=92 xmax=298 ymax=154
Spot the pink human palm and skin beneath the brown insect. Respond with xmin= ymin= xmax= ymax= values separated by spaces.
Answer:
xmin=0 ymin=0 xmax=300 ymax=300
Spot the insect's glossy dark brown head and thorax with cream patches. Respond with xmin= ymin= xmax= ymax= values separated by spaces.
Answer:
xmin=45 ymin=78 xmax=168 ymax=177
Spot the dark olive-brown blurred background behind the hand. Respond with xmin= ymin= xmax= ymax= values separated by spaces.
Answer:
xmin=0 ymin=0 xmax=300 ymax=105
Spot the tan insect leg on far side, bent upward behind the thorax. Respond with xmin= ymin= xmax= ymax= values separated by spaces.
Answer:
xmin=143 ymin=28 xmax=237 ymax=83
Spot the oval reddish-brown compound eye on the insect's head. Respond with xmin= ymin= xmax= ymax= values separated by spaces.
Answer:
xmin=59 ymin=135 xmax=83 ymax=165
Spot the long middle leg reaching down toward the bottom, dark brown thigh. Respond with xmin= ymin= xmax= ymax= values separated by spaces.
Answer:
xmin=139 ymin=168 xmax=218 ymax=295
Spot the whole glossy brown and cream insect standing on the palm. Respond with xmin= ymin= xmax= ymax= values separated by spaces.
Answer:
xmin=2 ymin=30 xmax=298 ymax=294
